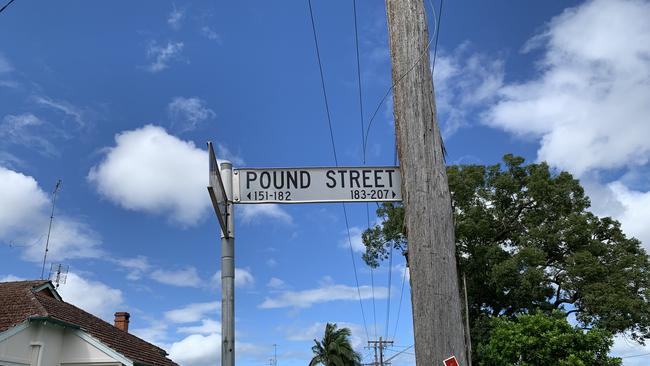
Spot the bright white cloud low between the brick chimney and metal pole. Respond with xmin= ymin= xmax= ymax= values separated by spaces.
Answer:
xmin=169 ymin=333 xmax=219 ymax=366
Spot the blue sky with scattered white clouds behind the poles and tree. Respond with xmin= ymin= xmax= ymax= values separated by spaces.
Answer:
xmin=0 ymin=0 xmax=650 ymax=366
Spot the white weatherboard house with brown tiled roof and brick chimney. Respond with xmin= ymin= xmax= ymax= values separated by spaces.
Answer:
xmin=0 ymin=281 xmax=177 ymax=366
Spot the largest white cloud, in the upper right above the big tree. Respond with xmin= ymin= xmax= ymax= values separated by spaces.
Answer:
xmin=486 ymin=0 xmax=650 ymax=175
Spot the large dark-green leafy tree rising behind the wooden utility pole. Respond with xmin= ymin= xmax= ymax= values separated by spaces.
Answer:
xmin=363 ymin=155 xmax=650 ymax=342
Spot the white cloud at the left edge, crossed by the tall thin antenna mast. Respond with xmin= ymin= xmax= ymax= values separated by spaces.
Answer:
xmin=0 ymin=167 xmax=102 ymax=262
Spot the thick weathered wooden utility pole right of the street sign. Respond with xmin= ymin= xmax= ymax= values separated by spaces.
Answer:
xmin=386 ymin=0 xmax=468 ymax=366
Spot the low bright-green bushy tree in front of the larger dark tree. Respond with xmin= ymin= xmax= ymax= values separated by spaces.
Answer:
xmin=476 ymin=311 xmax=621 ymax=366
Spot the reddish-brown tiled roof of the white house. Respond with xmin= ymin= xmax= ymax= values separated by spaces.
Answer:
xmin=0 ymin=280 xmax=177 ymax=366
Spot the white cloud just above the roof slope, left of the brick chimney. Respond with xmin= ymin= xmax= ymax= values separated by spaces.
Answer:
xmin=58 ymin=272 xmax=124 ymax=323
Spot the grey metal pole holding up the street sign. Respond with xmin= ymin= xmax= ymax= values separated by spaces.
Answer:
xmin=220 ymin=161 xmax=235 ymax=366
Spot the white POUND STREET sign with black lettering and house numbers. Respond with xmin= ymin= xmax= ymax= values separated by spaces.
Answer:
xmin=233 ymin=166 xmax=402 ymax=203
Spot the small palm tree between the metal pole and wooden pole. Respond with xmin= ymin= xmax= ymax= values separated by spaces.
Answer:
xmin=309 ymin=323 xmax=361 ymax=366
